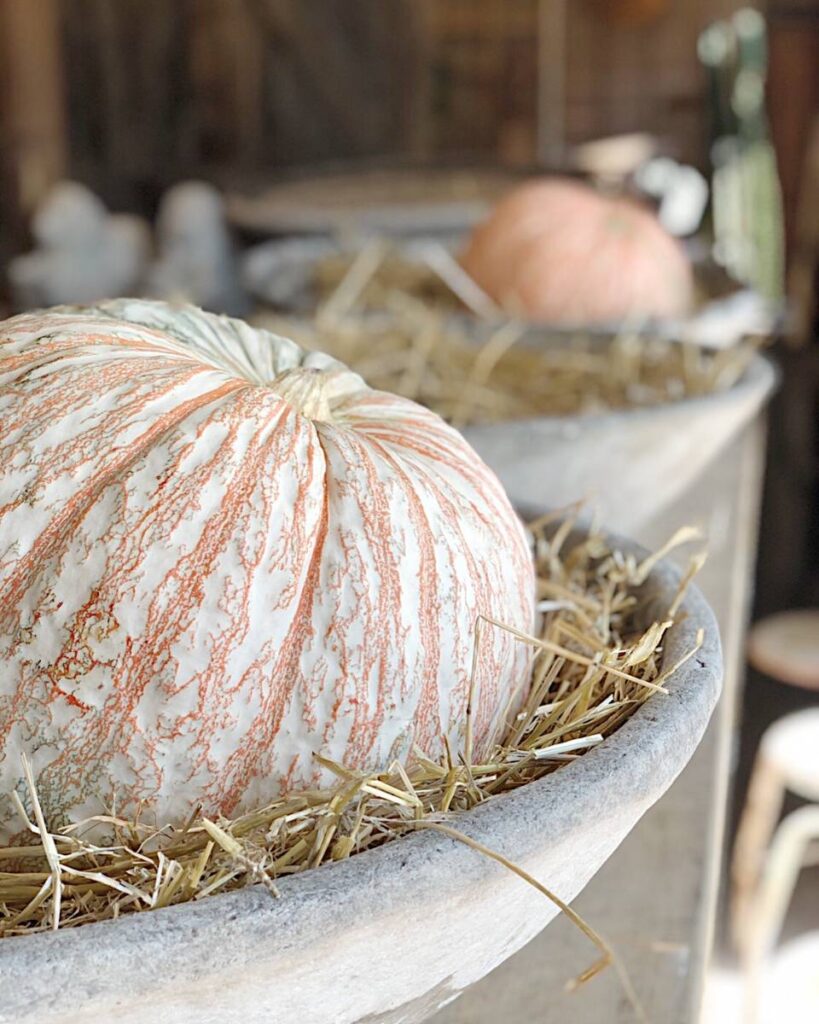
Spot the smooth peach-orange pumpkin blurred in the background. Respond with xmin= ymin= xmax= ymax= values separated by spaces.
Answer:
xmin=461 ymin=178 xmax=693 ymax=326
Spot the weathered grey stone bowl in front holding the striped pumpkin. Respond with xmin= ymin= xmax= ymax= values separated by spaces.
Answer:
xmin=0 ymin=540 xmax=722 ymax=1024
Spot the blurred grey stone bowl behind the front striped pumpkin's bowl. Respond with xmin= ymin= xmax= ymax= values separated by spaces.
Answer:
xmin=462 ymin=355 xmax=777 ymax=536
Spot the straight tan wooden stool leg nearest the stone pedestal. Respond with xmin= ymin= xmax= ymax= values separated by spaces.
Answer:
xmin=731 ymin=753 xmax=785 ymax=952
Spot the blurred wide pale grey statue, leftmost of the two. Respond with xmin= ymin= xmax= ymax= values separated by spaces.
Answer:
xmin=8 ymin=181 xmax=150 ymax=309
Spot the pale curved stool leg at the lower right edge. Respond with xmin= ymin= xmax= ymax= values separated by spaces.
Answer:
xmin=742 ymin=806 xmax=819 ymax=1024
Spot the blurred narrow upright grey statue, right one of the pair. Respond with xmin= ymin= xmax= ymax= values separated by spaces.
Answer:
xmin=146 ymin=181 xmax=247 ymax=315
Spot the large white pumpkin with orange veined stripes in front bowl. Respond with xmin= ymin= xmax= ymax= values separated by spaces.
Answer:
xmin=0 ymin=300 xmax=534 ymax=838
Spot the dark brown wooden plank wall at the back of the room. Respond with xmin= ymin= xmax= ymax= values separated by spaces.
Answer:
xmin=0 ymin=0 xmax=753 ymax=231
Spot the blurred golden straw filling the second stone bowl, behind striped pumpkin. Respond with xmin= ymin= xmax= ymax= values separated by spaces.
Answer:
xmin=254 ymin=305 xmax=763 ymax=427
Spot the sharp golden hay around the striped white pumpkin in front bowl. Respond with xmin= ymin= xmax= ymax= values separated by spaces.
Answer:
xmin=0 ymin=517 xmax=697 ymax=942
